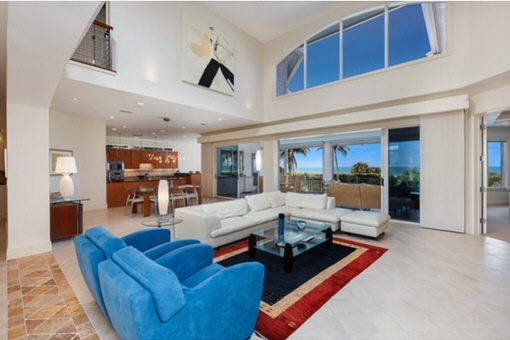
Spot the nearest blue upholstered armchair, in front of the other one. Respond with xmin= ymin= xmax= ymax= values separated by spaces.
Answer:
xmin=99 ymin=244 xmax=264 ymax=340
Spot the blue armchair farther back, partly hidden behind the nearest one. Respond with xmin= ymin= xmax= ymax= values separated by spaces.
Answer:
xmin=74 ymin=226 xmax=199 ymax=322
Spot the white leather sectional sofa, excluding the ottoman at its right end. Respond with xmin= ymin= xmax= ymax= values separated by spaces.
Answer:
xmin=175 ymin=191 xmax=352 ymax=248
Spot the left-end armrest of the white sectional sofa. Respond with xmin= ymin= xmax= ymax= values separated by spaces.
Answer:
xmin=175 ymin=207 xmax=221 ymax=244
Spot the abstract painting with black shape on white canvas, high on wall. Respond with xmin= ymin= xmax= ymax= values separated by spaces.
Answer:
xmin=181 ymin=12 xmax=234 ymax=96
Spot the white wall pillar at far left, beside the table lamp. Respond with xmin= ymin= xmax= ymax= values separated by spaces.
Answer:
xmin=7 ymin=104 xmax=51 ymax=259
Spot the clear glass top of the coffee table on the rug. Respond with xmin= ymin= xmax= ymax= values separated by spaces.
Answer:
xmin=252 ymin=220 xmax=331 ymax=247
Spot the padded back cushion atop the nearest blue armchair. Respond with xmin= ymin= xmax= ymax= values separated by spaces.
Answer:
xmin=112 ymin=247 xmax=186 ymax=322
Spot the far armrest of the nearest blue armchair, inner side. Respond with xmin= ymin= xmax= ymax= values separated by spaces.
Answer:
xmin=156 ymin=243 xmax=213 ymax=282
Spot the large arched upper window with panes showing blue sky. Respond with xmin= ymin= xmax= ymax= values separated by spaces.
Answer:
xmin=276 ymin=2 xmax=446 ymax=96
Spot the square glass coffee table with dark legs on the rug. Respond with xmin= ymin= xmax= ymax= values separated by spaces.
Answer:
xmin=248 ymin=220 xmax=333 ymax=273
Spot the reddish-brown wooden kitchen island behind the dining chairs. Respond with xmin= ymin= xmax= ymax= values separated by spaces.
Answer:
xmin=106 ymin=173 xmax=202 ymax=208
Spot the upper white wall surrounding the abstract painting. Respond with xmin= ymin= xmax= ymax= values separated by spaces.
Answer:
xmin=64 ymin=1 xmax=263 ymax=121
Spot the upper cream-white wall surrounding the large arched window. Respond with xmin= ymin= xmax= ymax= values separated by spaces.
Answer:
xmin=264 ymin=2 xmax=510 ymax=122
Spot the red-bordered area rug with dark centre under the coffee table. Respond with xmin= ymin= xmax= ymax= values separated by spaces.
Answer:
xmin=214 ymin=237 xmax=387 ymax=339
